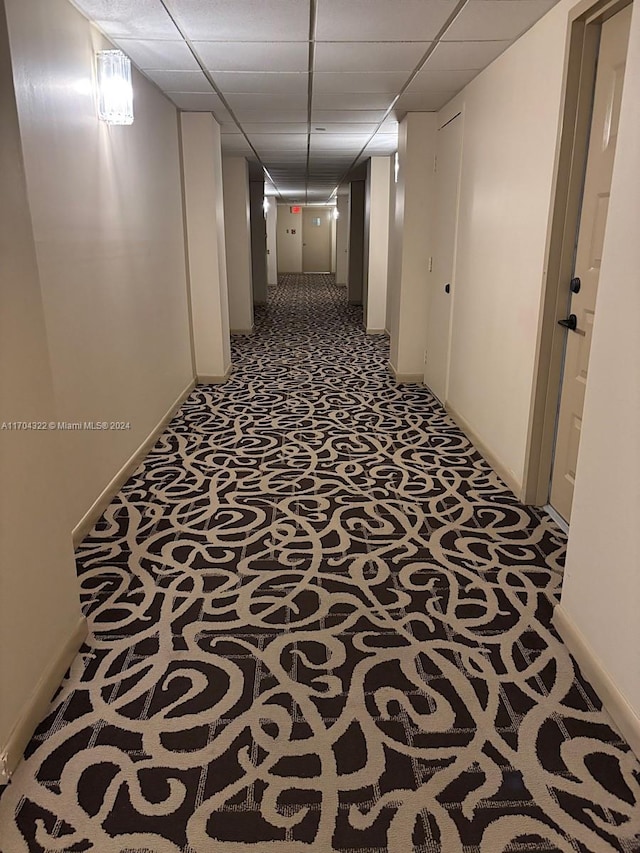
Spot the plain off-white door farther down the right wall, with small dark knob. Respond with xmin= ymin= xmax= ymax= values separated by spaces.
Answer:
xmin=424 ymin=115 xmax=462 ymax=403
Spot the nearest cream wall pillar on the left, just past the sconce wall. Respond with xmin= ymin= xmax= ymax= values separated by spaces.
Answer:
xmin=180 ymin=112 xmax=231 ymax=382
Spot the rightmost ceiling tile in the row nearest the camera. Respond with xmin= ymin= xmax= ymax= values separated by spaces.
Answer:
xmin=444 ymin=0 xmax=557 ymax=41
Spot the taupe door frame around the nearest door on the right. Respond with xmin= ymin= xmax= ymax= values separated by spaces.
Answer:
xmin=521 ymin=0 xmax=632 ymax=506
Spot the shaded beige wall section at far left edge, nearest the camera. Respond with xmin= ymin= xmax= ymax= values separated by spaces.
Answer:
xmin=0 ymin=2 xmax=81 ymax=782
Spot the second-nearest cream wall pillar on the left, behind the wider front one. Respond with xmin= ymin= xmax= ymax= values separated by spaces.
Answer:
xmin=222 ymin=157 xmax=253 ymax=332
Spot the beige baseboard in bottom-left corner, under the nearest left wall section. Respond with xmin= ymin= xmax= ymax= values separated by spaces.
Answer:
xmin=0 ymin=616 xmax=87 ymax=783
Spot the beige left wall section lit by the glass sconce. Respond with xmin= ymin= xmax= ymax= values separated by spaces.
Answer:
xmin=6 ymin=0 xmax=193 ymax=530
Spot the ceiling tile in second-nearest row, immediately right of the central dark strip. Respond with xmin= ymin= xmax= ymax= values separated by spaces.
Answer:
xmin=314 ymin=42 xmax=430 ymax=74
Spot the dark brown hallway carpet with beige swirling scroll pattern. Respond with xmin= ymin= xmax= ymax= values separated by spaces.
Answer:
xmin=0 ymin=275 xmax=640 ymax=853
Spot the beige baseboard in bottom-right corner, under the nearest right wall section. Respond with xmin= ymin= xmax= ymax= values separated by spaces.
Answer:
xmin=552 ymin=604 xmax=640 ymax=758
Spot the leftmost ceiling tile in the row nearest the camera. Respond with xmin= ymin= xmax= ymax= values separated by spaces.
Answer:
xmin=72 ymin=0 xmax=180 ymax=41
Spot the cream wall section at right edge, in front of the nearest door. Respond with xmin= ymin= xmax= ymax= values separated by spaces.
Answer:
xmin=562 ymin=0 xmax=640 ymax=736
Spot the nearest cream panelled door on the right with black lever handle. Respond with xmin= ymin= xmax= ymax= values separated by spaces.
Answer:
xmin=550 ymin=6 xmax=631 ymax=521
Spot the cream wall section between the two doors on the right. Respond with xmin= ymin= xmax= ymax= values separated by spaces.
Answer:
xmin=438 ymin=0 xmax=573 ymax=484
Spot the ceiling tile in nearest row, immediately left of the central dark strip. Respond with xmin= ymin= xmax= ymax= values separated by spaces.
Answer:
xmin=167 ymin=0 xmax=309 ymax=41
